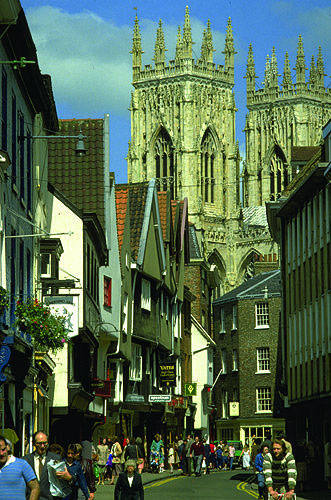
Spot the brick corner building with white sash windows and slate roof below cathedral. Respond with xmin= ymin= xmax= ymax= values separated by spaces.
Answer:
xmin=213 ymin=270 xmax=285 ymax=443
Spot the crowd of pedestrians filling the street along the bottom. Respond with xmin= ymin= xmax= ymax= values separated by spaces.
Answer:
xmin=0 ymin=430 xmax=297 ymax=500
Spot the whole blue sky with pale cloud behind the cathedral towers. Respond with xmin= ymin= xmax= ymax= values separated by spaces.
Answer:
xmin=21 ymin=0 xmax=331 ymax=182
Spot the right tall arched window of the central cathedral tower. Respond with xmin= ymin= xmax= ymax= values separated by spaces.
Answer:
xmin=200 ymin=130 xmax=216 ymax=203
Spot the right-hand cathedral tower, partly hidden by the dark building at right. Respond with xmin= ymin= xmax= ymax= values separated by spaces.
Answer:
xmin=243 ymin=36 xmax=331 ymax=207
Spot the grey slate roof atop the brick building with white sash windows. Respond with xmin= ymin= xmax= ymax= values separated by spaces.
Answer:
xmin=214 ymin=269 xmax=281 ymax=304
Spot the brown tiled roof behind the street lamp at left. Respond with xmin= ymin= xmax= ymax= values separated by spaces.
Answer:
xmin=47 ymin=118 xmax=105 ymax=227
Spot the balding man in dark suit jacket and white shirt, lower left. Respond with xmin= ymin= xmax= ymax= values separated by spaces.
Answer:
xmin=23 ymin=431 xmax=64 ymax=500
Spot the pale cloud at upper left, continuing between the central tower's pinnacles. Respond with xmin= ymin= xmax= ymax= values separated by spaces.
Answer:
xmin=26 ymin=6 xmax=225 ymax=118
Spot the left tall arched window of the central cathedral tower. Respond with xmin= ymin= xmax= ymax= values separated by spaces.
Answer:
xmin=154 ymin=129 xmax=175 ymax=199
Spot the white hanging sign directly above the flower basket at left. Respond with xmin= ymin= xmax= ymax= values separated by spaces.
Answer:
xmin=44 ymin=295 xmax=79 ymax=337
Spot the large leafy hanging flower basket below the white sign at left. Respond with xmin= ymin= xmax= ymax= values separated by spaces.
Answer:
xmin=15 ymin=299 xmax=68 ymax=353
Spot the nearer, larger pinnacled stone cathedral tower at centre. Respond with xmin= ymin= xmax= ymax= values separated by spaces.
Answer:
xmin=127 ymin=7 xmax=239 ymax=226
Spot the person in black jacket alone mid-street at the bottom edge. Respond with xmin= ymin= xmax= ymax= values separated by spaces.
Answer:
xmin=114 ymin=460 xmax=144 ymax=500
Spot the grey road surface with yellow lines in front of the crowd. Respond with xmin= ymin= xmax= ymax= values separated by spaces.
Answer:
xmin=95 ymin=471 xmax=258 ymax=500
